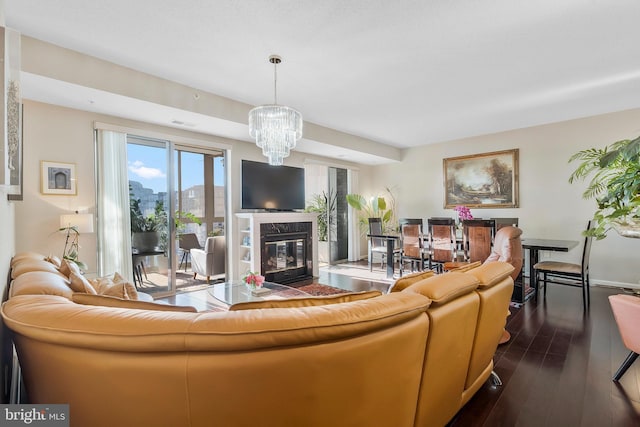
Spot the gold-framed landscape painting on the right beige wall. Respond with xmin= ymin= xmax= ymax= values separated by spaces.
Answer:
xmin=443 ymin=149 xmax=518 ymax=208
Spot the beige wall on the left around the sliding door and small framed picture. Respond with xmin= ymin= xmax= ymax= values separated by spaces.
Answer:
xmin=15 ymin=101 xmax=364 ymax=276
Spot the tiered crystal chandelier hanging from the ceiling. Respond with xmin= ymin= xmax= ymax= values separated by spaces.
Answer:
xmin=249 ymin=55 xmax=302 ymax=166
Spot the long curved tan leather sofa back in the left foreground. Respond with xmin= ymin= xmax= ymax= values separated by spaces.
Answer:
xmin=2 ymin=293 xmax=430 ymax=426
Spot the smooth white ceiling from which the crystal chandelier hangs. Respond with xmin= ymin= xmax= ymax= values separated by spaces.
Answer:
xmin=4 ymin=0 xmax=640 ymax=164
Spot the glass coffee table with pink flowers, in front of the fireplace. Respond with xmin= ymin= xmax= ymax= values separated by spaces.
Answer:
xmin=208 ymin=280 xmax=310 ymax=305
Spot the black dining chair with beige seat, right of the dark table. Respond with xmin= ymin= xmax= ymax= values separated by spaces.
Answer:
xmin=533 ymin=221 xmax=592 ymax=310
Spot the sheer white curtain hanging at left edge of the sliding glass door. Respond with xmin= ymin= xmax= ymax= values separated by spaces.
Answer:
xmin=96 ymin=129 xmax=133 ymax=281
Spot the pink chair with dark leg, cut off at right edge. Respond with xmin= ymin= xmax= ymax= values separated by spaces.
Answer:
xmin=609 ymin=295 xmax=640 ymax=382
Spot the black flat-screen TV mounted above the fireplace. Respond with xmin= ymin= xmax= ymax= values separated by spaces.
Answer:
xmin=242 ymin=160 xmax=305 ymax=211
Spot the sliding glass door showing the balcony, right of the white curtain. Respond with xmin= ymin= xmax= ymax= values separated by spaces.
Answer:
xmin=127 ymin=139 xmax=225 ymax=294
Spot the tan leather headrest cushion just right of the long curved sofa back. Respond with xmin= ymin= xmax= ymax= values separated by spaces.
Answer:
xmin=404 ymin=272 xmax=478 ymax=306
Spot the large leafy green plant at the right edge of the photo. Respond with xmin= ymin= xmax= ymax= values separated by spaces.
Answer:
xmin=569 ymin=137 xmax=640 ymax=240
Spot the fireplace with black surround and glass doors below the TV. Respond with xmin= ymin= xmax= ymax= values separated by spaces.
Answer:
xmin=260 ymin=222 xmax=313 ymax=284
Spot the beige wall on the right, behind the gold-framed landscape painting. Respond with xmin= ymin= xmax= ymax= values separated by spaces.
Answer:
xmin=364 ymin=109 xmax=640 ymax=286
